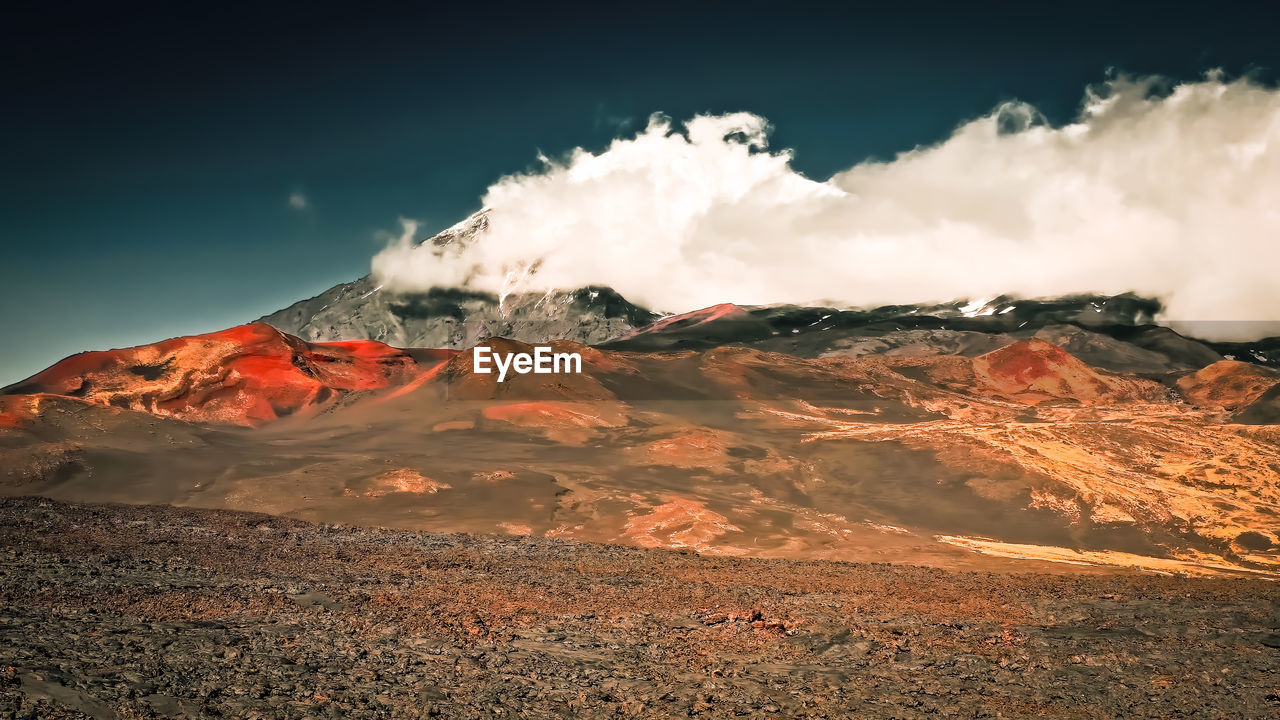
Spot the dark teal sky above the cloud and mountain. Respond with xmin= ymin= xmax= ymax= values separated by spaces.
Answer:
xmin=0 ymin=1 xmax=1280 ymax=384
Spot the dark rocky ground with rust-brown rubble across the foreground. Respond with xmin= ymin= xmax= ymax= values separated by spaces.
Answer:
xmin=0 ymin=498 xmax=1280 ymax=719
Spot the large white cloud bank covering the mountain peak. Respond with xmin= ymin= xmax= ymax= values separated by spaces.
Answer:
xmin=372 ymin=74 xmax=1280 ymax=336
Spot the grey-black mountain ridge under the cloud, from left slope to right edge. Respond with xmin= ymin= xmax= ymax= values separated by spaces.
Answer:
xmin=259 ymin=209 xmax=1280 ymax=373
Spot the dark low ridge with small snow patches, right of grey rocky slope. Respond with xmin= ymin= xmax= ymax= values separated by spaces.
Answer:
xmin=605 ymin=295 xmax=1280 ymax=374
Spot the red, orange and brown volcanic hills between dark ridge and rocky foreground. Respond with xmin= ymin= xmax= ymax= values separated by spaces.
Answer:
xmin=0 ymin=322 xmax=1280 ymax=575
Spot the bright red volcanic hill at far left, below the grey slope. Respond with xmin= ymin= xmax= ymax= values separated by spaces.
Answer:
xmin=3 ymin=323 xmax=432 ymax=425
